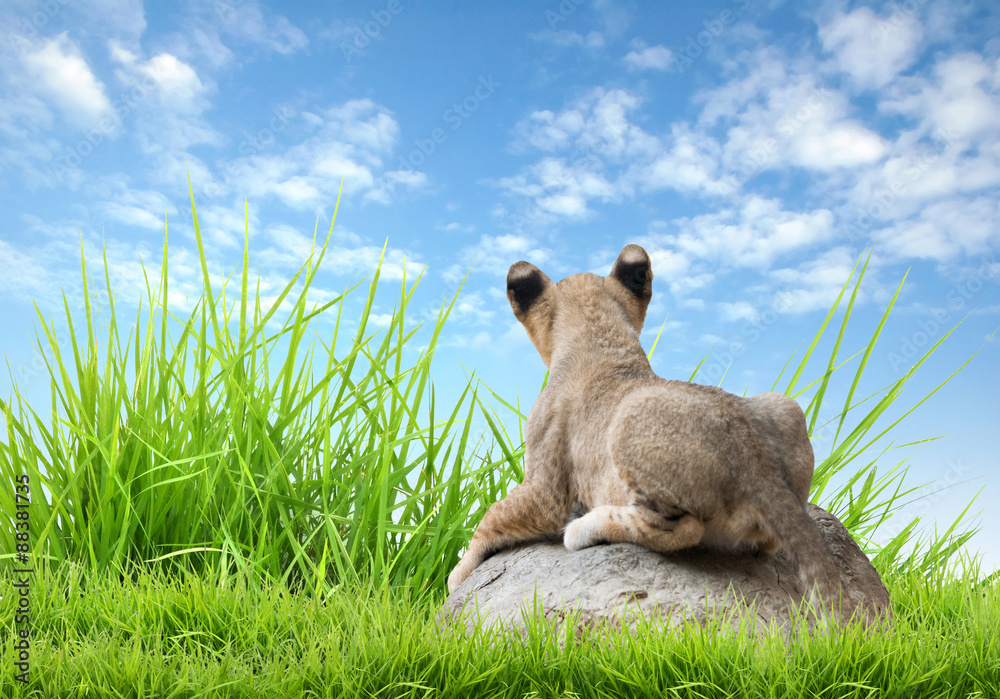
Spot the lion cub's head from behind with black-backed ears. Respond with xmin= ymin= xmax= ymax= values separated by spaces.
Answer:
xmin=507 ymin=245 xmax=653 ymax=366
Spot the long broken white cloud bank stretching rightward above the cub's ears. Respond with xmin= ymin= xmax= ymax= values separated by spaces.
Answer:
xmin=498 ymin=54 xmax=890 ymax=224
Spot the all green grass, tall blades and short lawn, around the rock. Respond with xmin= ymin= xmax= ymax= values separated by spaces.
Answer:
xmin=0 ymin=189 xmax=1000 ymax=697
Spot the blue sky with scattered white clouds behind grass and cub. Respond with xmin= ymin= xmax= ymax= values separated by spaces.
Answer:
xmin=0 ymin=0 xmax=1000 ymax=567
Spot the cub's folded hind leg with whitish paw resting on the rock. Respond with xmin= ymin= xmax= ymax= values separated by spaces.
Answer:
xmin=563 ymin=505 xmax=705 ymax=553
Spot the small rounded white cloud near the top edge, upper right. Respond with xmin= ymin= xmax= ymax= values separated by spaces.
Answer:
xmin=819 ymin=7 xmax=923 ymax=88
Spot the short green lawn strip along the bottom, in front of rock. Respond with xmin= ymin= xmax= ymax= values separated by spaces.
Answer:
xmin=0 ymin=568 xmax=1000 ymax=697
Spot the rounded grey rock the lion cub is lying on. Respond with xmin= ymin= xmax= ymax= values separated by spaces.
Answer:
xmin=439 ymin=505 xmax=892 ymax=632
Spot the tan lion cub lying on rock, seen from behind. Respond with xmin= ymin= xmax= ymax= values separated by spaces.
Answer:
xmin=448 ymin=245 xmax=840 ymax=606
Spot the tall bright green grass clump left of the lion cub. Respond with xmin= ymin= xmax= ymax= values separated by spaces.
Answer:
xmin=0 ymin=191 xmax=511 ymax=594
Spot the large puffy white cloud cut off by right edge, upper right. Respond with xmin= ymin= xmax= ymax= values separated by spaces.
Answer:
xmin=843 ymin=53 xmax=1000 ymax=254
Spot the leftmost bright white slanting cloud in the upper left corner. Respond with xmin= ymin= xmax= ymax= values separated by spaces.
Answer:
xmin=23 ymin=32 xmax=117 ymax=128
